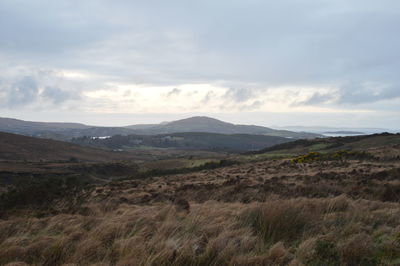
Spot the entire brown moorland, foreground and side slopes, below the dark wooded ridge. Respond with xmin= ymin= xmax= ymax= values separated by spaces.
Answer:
xmin=0 ymin=118 xmax=400 ymax=266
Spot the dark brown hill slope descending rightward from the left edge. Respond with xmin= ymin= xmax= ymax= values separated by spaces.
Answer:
xmin=0 ymin=132 xmax=137 ymax=162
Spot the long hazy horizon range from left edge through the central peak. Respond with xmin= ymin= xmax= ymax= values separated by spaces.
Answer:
xmin=0 ymin=116 xmax=322 ymax=141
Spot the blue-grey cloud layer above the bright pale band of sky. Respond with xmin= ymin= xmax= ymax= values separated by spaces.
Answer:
xmin=0 ymin=0 xmax=400 ymax=127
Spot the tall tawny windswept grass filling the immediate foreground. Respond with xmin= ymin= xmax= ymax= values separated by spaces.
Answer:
xmin=0 ymin=196 xmax=400 ymax=266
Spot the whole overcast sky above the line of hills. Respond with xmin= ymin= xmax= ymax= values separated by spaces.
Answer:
xmin=0 ymin=0 xmax=400 ymax=128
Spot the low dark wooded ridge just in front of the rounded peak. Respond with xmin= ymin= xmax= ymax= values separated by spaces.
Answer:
xmin=72 ymin=132 xmax=293 ymax=152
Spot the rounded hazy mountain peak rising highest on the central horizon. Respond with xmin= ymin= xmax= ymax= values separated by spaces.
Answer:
xmin=128 ymin=116 xmax=321 ymax=139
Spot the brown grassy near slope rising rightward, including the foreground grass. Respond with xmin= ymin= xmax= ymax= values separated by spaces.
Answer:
xmin=0 ymin=135 xmax=400 ymax=266
